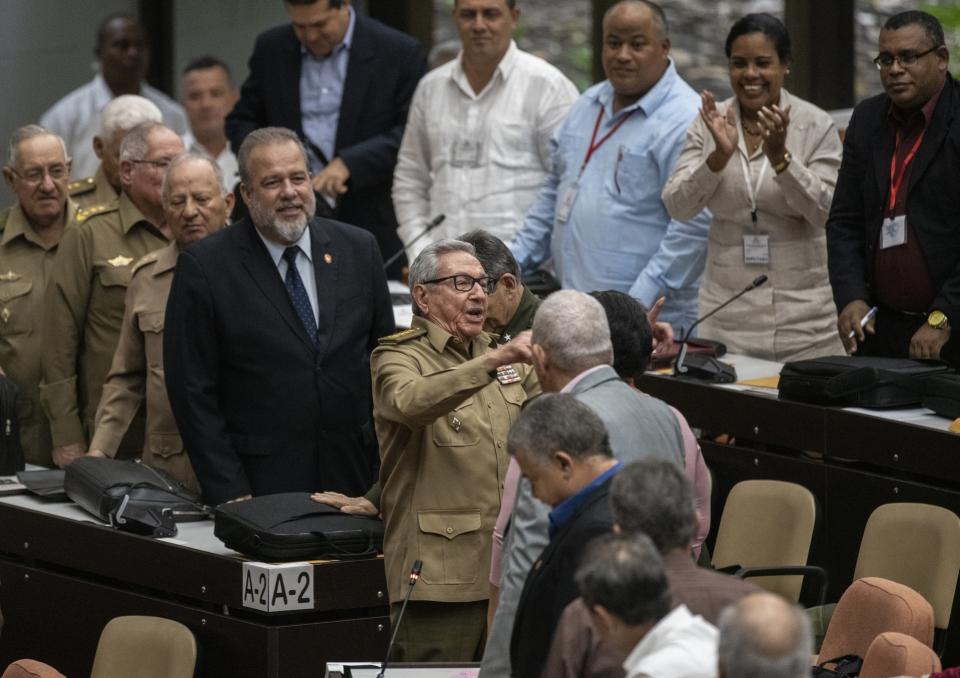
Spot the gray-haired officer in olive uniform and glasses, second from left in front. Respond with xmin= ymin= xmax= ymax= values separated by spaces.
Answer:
xmin=41 ymin=123 xmax=183 ymax=466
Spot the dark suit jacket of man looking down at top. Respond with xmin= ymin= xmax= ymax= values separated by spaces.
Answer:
xmin=226 ymin=12 xmax=427 ymax=274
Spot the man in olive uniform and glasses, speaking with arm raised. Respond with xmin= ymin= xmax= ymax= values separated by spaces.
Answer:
xmin=371 ymin=240 xmax=539 ymax=661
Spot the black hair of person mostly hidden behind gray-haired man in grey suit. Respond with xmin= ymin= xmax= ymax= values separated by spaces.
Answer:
xmin=590 ymin=290 xmax=653 ymax=379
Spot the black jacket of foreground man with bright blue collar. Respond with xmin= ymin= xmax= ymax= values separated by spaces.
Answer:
xmin=510 ymin=478 xmax=613 ymax=678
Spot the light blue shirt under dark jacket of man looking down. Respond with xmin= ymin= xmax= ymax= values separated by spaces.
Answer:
xmin=300 ymin=6 xmax=357 ymax=173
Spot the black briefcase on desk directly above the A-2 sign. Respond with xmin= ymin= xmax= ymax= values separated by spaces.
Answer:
xmin=213 ymin=492 xmax=383 ymax=560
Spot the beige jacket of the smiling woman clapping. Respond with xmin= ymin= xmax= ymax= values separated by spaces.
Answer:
xmin=663 ymin=90 xmax=843 ymax=361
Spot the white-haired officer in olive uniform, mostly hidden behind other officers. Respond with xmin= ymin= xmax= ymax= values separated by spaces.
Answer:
xmin=67 ymin=94 xmax=163 ymax=214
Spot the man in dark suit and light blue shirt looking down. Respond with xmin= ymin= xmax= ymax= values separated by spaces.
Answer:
xmin=226 ymin=0 xmax=426 ymax=274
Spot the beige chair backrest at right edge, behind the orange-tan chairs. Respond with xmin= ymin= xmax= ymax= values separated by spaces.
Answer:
xmin=853 ymin=503 xmax=960 ymax=629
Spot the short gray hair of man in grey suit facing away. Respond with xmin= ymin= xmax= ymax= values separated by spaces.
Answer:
xmin=531 ymin=290 xmax=613 ymax=374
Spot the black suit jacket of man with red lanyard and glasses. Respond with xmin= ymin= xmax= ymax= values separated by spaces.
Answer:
xmin=827 ymin=74 xmax=960 ymax=324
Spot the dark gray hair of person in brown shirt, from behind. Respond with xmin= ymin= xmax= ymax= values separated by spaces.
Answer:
xmin=610 ymin=459 xmax=697 ymax=553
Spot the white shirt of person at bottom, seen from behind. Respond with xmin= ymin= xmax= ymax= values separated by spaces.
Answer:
xmin=623 ymin=605 xmax=719 ymax=678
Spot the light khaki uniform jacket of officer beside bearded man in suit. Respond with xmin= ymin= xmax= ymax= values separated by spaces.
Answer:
xmin=90 ymin=243 xmax=200 ymax=493
